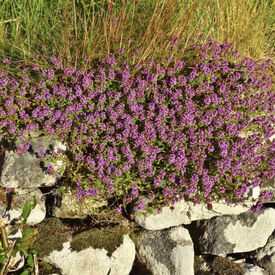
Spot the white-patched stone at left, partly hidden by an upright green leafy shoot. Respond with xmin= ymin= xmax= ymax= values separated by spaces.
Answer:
xmin=0 ymin=188 xmax=46 ymax=225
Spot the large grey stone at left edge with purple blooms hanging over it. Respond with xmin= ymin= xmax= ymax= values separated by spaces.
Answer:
xmin=0 ymin=132 xmax=66 ymax=189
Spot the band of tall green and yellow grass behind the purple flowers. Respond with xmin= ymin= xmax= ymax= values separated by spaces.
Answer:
xmin=0 ymin=0 xmax=275 ymax=69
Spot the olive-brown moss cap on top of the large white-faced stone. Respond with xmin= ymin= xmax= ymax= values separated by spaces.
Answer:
xmin=71 ymin=225 xmax=130 ymax=257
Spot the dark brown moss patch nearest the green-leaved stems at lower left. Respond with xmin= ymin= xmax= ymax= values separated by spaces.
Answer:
xmin=34 ymin=218 xmax=69 ymax=258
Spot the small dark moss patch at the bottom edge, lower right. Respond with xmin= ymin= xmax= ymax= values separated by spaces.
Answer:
xmin=213 ymin=257 xmax=245 ymax=275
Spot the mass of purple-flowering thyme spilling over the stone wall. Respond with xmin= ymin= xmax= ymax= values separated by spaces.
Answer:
xmin=0 ymin=36 xmax=275 ymax=216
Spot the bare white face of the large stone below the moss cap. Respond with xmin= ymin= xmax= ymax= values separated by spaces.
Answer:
xmin=46 ymin=235 xmax=135 ymax=275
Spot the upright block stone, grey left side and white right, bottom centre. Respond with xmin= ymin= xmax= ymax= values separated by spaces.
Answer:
xmin=137 ymin=226 xmax=194 ymax=275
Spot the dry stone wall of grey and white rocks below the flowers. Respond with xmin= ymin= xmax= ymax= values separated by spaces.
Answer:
xmin=0 ymin=132 xmax=275 ymax=275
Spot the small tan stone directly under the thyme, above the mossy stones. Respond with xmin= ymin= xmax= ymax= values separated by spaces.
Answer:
xmin=53 ymin=190 xmax=108 ymax=219
